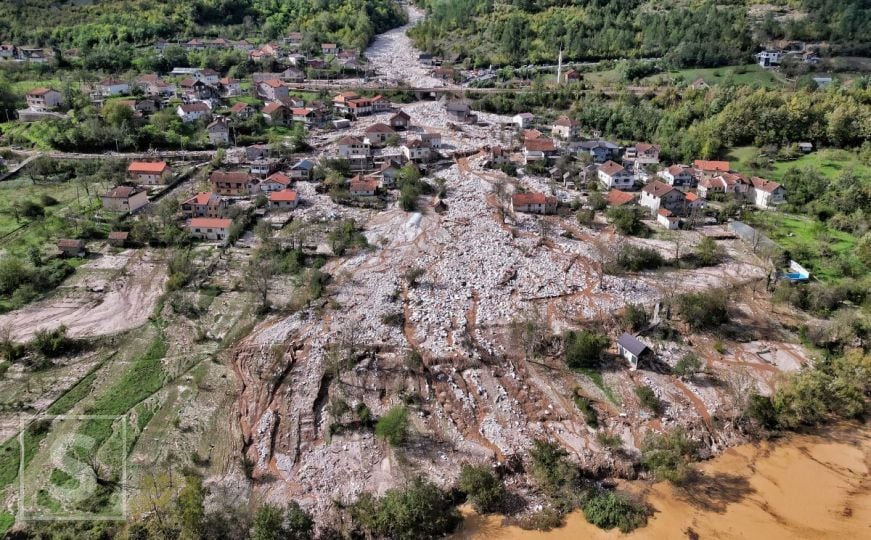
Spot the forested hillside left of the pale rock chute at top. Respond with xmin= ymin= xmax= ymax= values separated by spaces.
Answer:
xmin=0 ymin=0 xmax=404 ymax=50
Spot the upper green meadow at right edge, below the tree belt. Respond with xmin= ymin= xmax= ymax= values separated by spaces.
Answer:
xmin=728 ymin=146 xmax=871 ymax=181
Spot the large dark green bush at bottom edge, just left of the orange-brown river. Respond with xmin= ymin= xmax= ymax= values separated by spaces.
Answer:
xmin=351 ymin=477 xmax=462 ymax=539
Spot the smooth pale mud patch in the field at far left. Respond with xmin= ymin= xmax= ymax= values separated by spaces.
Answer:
xmin=0 ymin=251 xmax=166 ymax=341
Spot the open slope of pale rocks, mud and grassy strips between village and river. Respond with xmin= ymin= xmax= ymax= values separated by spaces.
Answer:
xmin=0 ymin=96 xmax=806 ymax=519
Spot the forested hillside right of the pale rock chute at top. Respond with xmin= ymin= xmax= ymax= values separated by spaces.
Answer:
xmin=412 ymin=0 xmax=871 ymax=67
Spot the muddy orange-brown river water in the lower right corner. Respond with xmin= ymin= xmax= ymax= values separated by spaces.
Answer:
xmin=453 ymin=425 xmax=871 ymax=540
